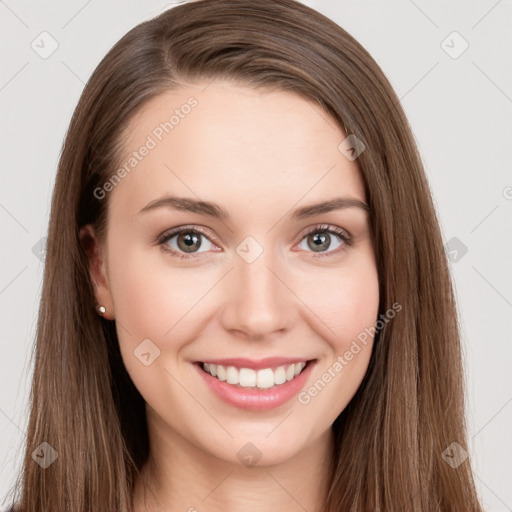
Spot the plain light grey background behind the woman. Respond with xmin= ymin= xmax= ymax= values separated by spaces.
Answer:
xmin=0 ymin=0 xmax=512 ymax=512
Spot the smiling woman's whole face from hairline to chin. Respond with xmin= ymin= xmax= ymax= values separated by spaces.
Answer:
xmin=86 ymin=81 xmax=379 ymax=465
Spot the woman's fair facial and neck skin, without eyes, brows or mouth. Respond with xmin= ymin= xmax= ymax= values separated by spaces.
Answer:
xmin=82 ymin=81 xmax=379 ymax=512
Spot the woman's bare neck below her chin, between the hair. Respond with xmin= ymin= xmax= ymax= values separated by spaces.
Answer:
xmin=133 ymin=412 xmax=334 ymax=512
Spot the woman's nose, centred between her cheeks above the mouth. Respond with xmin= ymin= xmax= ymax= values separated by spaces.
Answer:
xmin=221 ymin=247 xmax=296 ymax=340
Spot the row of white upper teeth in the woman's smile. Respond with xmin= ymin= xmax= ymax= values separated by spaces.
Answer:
xmin=203 ymin=362 xmax=306 ymax=389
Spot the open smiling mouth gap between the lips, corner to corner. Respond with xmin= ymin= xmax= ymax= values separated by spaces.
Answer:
xmin=194 ymin=359 xmax=316 ymax=390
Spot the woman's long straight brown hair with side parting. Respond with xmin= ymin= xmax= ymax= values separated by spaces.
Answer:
xmin=8 ymin=0 xmax=482 ymax=512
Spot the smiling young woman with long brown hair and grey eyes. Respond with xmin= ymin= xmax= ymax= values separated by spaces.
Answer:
xmin=5 ymin=0 xmax=482 ymax=512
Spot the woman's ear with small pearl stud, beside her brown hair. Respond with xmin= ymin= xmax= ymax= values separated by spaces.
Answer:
xmin=79 ymin=224 xmax=115 ymax=320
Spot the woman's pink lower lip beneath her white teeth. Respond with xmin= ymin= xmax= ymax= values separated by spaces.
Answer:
xmin=194 ymin=360 xmax=316 ymax=411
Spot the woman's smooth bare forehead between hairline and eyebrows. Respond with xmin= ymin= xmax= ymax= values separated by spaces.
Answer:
xmin=112 ymin=81 xmax=365 ymax=220
